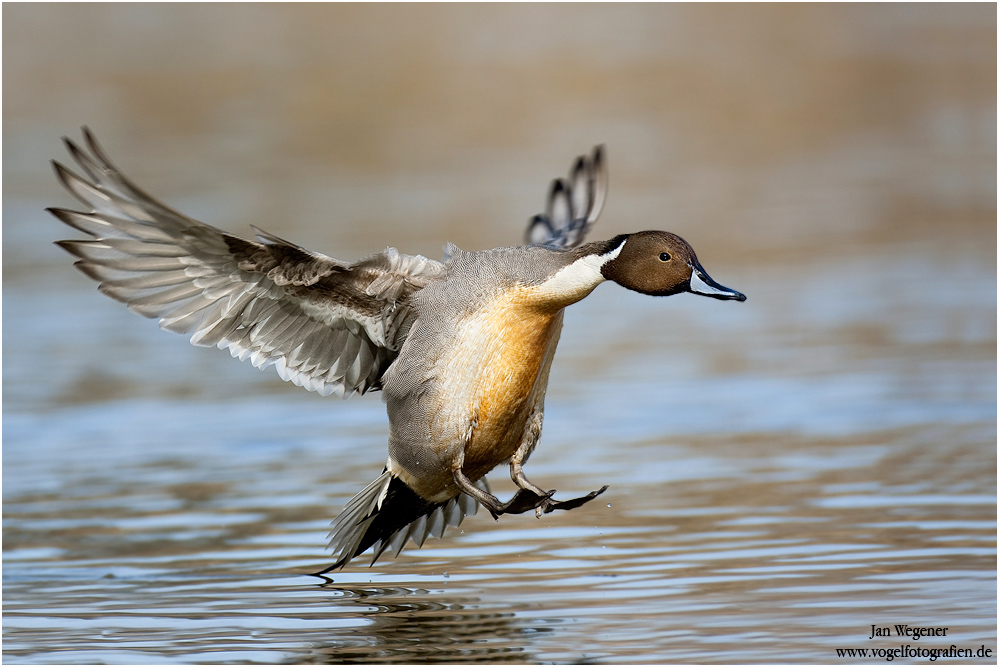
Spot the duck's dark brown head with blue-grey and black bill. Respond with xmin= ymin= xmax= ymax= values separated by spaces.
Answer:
xmin=600 ymin=231 xmax=746 ymax=301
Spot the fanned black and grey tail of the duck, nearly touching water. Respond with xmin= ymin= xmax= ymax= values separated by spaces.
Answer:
xmin=317 ymin=470 xmax=489 ymax=574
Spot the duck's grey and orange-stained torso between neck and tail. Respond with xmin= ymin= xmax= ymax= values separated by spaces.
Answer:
xmin=384 ymin=268 xmax=563 ymax=500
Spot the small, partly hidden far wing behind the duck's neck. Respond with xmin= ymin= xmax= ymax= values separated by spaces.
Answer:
xmin=524 ymin=146 xmax=607 ymax=249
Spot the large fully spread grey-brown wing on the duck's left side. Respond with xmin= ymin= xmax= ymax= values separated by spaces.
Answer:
xmin=48 ymin=128 xmax=444 ymax=396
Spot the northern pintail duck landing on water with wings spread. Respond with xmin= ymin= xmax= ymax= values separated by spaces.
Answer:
xmin=49 ymin=128 xmax=746 ymax=574
